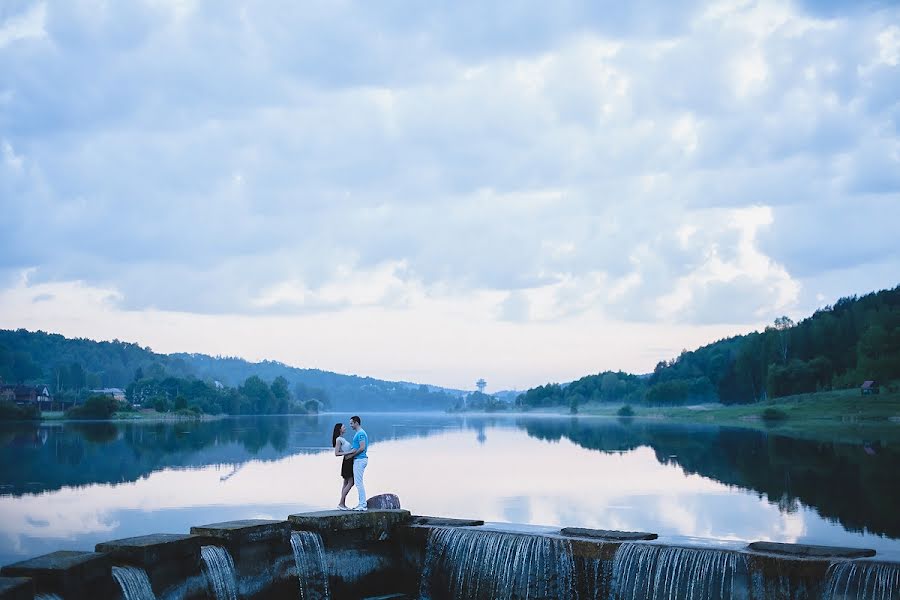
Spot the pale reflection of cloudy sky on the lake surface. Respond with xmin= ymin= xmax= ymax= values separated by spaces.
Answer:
xmin=0 ymin=426 xmax=898 ymax=555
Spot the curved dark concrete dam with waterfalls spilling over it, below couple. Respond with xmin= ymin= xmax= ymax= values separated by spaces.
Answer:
xmin=0 ymin=495 xmax=900 ymax=600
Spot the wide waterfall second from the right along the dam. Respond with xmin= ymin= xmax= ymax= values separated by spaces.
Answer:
xmin=612 ymin=544 xmax=750 ymax=600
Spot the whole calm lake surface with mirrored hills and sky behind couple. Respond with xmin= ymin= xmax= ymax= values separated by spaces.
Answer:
xmin=0 ymin=414 xmax=900 ymax=565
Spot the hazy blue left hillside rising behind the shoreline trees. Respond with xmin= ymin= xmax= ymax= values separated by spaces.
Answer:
xmin=0 ymin=329 xmax=465 ymax=410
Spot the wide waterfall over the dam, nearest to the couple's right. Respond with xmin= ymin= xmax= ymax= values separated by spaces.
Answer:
xmin=419 ymin=527 xmax=576 ymax=600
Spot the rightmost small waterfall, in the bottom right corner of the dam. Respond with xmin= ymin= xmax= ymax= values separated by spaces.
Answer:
xmin=822 ymin=560 xmax=900 ymax=600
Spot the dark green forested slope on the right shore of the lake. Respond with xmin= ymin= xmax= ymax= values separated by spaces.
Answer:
xmin=516 ymin=286 xmax=900 ymax=411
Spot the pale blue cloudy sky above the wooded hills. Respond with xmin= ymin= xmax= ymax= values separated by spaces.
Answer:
xmin=0 ymin=0 xmax=900 ymax=391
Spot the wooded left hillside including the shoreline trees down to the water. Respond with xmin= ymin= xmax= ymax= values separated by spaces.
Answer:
xmin=0 ymin=329 xmax=456 ymax=414
